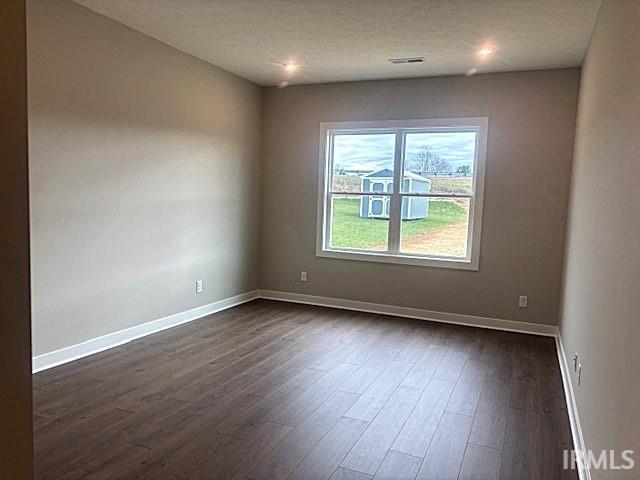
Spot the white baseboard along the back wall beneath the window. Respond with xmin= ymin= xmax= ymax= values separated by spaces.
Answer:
xmin=258 ymin=290 xmax=558 ymax=337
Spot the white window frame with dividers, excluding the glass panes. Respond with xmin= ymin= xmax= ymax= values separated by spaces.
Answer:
xmin=316 ymin=117 xmax=489 ymax=270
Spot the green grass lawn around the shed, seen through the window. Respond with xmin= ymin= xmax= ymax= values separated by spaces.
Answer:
xmin=331 ymin=198 xmax=467 ymax=249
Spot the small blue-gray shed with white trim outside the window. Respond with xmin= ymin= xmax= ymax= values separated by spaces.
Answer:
xmin=360 ymin=168 xmax=431 ymax=220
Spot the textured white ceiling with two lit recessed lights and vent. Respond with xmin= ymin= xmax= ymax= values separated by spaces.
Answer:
xmin=76 ymin=0 xmax=600 ymax=85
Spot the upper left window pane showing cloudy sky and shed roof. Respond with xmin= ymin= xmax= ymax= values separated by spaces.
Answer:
xmin=332 ymin=133 xmax=395 ymax=192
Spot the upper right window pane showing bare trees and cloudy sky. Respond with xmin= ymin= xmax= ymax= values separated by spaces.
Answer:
xmin=402 ymin=132 xmax=476 ymax=193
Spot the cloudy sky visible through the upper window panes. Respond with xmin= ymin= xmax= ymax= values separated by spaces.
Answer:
xmin=334 ymin=132 xmax=475 ymax=171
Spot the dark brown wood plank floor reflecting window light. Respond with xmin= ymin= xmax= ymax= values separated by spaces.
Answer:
xmin=33 ymin=300 xmax=577 ymax=480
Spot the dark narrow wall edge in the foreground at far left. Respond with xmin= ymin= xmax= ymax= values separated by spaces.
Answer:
xmin=0 ymin=0 xmax=33 ymax=474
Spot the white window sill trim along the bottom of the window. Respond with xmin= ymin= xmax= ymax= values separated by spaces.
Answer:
xmin=316 ymin=250 xmax=478 ymax=271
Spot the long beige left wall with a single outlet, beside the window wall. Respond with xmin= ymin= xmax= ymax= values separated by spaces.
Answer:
xmin=28 ymin=0 xmax=262 ymax=355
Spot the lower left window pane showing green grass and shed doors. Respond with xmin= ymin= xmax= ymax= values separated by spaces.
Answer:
xmin=331 ymin=195 xmax=390 ymax=251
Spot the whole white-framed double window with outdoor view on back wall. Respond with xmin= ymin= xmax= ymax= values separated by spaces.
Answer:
xmin=316 ymin=118 xmax=488 ymax=270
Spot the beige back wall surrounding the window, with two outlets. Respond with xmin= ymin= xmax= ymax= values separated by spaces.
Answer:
xmin=261 ymin=69 xmax=579 ymax=324
